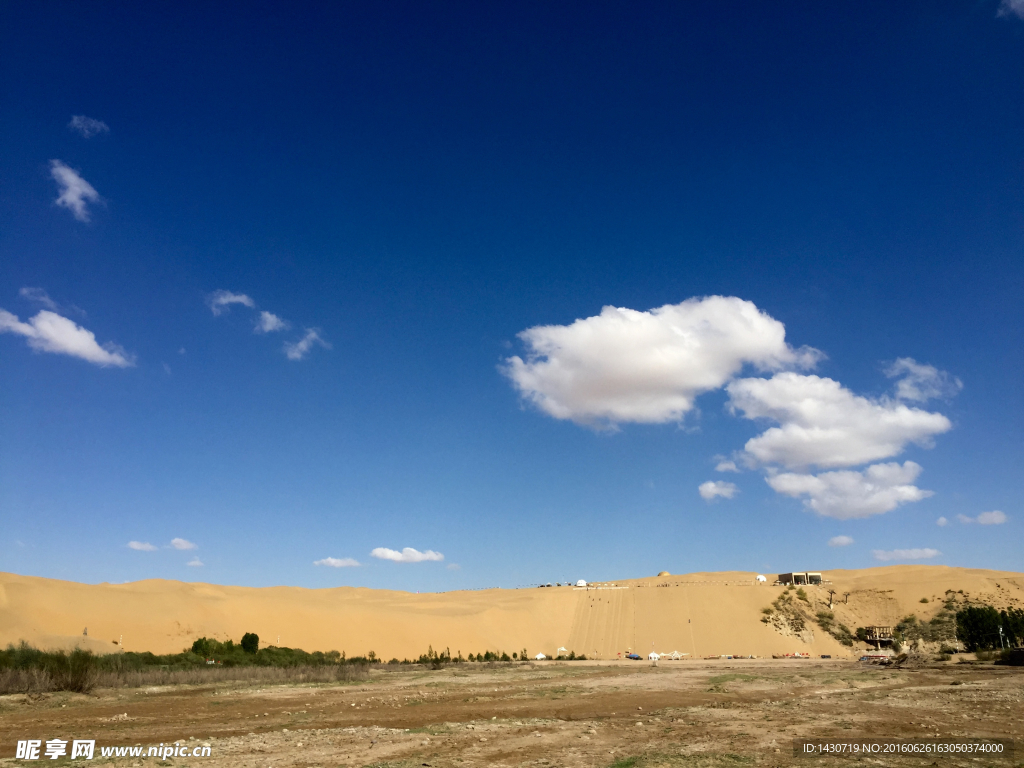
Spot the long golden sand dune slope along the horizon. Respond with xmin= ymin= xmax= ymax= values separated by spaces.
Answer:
xmin=0 ymin=565 xmax=1024 ymax=658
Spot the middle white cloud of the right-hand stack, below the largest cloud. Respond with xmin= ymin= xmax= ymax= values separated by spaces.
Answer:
xmin=726 ymin=372 xmax=952 ymax=468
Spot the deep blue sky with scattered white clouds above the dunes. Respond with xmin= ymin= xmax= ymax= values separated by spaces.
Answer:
xmin=0 ymin=0 xmax=1024 ymax=590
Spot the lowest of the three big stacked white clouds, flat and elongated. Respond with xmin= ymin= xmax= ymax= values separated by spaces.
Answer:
xmin=765 ymin=462 xmax=933 ymax=520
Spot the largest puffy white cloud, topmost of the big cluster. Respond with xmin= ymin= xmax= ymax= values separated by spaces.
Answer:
xmin=502 ymin=296 xmax=821 ymax=425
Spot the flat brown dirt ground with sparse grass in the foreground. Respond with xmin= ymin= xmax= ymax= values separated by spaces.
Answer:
xmin=0 ymin=659 xmax=1024 ymax=768
